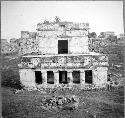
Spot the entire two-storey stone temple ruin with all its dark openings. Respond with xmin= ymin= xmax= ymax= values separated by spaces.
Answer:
xmin=18 ymin=17 xmax=108 ymax=88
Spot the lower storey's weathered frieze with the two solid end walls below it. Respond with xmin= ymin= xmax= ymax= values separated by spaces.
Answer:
xmin=18 ymin=54 xmax=108 ymax=87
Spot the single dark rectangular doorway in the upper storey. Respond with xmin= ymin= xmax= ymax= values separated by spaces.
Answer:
xmin=58 ymin=40 xmax=68 ymax=54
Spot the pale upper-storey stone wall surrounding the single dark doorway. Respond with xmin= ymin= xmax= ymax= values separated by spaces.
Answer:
xmin=37 ymin=22 xmax=88 ymax=54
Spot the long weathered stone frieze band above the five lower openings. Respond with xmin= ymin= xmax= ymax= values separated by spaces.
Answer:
xmin=19 ymin=53 xmax=108 ymax=69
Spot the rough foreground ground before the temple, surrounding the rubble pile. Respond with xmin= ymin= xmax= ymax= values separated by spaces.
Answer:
xmin=2 ymin=87 xmax=124 ymax=118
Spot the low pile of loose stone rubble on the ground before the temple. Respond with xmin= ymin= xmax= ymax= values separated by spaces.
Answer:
xmin=41 ymin=95 xmax=79 ymax=111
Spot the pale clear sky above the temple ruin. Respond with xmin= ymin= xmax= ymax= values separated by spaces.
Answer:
xmin=1 ymin=1 xmax=124 ymax=40
